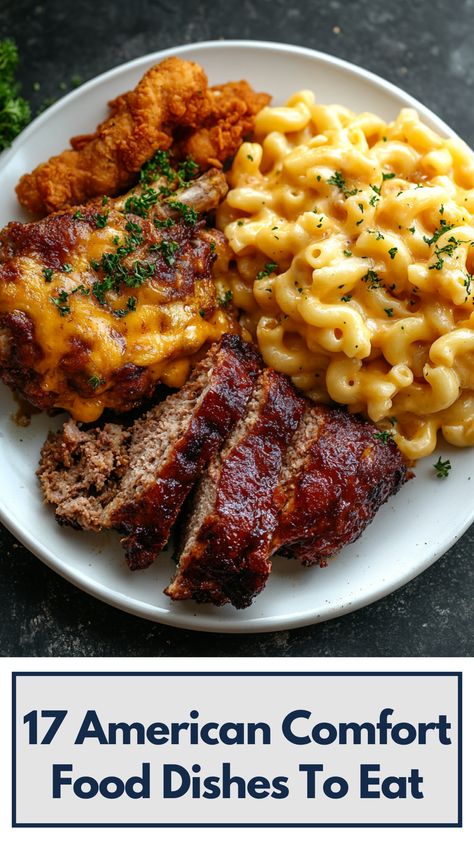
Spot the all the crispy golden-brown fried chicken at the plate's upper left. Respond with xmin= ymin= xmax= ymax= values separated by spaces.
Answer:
xmin=16 ymin=56 xmax=270 ymax=216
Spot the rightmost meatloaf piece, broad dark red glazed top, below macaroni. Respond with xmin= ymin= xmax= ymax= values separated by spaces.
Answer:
xmin=272 ymin=403 xmax=407 ymax=567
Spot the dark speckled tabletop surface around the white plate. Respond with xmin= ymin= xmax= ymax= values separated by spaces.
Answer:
xmin=0 ymin=0 xmax=474 ymax=657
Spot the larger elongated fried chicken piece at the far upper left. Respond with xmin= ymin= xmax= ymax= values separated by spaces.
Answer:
xmin=16 ymin=57 xmax=210 ymax=215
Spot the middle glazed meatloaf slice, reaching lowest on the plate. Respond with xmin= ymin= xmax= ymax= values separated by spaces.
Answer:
xmin=165 ymin=369 xmax=304 ymax=608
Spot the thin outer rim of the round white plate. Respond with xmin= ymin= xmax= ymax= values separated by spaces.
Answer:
xmin=0 ymin=39 xmax=474 ymax=634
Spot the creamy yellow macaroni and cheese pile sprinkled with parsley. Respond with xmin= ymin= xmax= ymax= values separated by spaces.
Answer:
xmin=217 ymin=91 xmax=474 ymax=459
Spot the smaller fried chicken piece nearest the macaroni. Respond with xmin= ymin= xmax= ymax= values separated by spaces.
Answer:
xmin=173 ymin=80 xmax=271 ymax=170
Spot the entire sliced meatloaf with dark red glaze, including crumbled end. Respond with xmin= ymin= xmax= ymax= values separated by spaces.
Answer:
xmin=38 ymin=334 xmax=407 ymax=608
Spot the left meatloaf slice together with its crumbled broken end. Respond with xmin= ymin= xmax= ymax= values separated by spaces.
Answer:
xmin=38 ymin=334 xmax=260 ymax=569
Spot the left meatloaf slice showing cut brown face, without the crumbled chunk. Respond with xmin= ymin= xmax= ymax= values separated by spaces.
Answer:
xmin=103 ymin=334 xmax=261 ymax=570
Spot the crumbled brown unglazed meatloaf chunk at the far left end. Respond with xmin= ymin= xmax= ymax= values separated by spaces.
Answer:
xmin=37 ymin=419 xmax=130 ymax=532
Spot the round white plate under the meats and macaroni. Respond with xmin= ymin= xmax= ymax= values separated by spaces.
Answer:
xmin=0 ymin=41 xmax=474 ymax=632
